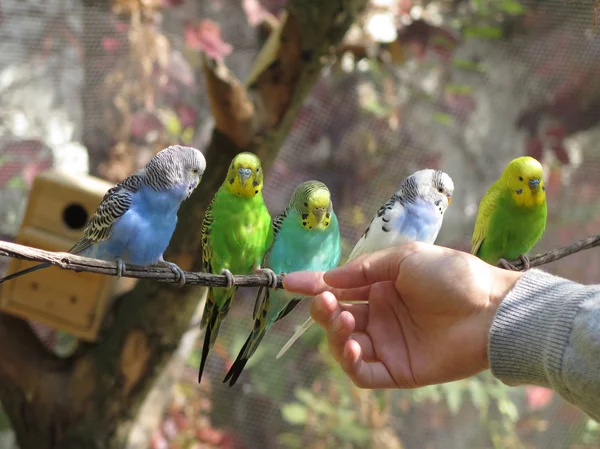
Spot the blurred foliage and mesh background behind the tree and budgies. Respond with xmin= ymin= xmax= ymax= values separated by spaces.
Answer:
xmin=0 ymin=0 xmax=600 ymax=449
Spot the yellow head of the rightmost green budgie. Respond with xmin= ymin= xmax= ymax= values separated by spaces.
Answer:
xmin=502 ymin=156 xmax=546 ymax=207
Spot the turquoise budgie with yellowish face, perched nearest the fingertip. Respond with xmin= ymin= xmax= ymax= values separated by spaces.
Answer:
xmin=224 ymin=181 xmax=341 ymax=386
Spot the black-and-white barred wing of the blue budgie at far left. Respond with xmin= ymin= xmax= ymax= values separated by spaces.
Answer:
xmin=69 ymin=174 xmax=143 ymax=254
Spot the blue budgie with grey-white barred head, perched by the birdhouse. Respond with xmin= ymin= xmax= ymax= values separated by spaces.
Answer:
xmin=0 ymin=145 xmax=206 ymax=285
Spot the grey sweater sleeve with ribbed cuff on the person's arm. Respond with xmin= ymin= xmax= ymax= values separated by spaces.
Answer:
xmin=488 ymin=269 xmax=600 ymax=421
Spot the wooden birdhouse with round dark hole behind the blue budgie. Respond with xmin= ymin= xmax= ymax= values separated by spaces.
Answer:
xmin=0 ymin=170 xmax=135 ymax=341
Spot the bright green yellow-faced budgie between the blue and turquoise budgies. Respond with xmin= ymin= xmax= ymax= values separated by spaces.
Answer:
xmin=198 ymin=152 xmax=277 ymax=382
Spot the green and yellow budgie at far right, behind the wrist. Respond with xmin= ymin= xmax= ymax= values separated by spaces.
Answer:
xmin=471 ymin=156 xmax=547 ymax=270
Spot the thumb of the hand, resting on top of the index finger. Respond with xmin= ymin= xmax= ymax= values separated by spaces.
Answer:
xmin=324 ymin=242 xmax=426 ymax=289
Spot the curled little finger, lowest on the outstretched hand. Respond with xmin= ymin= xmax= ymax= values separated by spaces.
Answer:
xmin=339 ymin=340 xmax=397 ymax=388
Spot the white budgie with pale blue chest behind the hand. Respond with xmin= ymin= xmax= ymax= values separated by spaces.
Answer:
xmin=277 ymin=169 xmax=454 ymax=358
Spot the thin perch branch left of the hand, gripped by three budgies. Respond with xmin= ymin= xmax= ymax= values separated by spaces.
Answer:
xmin=0 ymin=240 xmax=283 ymax=288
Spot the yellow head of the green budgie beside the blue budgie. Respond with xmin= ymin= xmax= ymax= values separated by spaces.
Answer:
xmin=225 ymin=153 xmax=263 ymax=198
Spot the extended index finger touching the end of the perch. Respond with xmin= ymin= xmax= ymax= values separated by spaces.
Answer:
xmin=283 ymin=271 xmax=370 ymax=301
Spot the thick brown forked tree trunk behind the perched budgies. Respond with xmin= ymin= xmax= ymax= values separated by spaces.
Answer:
xmin=0 ymin=0 xmax=367 ymax=449
